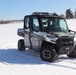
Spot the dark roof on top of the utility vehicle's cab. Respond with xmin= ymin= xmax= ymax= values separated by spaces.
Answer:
xmin=25 ymin=12 xmax=63 ymax=18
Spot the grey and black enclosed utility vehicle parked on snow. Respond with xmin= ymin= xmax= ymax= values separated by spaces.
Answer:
xmin=17 ymin=12 xmax=76 ymax=62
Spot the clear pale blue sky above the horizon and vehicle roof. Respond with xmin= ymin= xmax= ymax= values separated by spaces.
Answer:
xmin=0 ymin=0 xmax=76 ymax=20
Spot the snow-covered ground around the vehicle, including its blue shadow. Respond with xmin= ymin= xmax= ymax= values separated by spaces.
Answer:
xmin=0 ymin=20 xmax=76 ymax=75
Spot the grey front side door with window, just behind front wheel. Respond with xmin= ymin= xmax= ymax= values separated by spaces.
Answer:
xmin=30 ymin=17 xmax=40 ymax=50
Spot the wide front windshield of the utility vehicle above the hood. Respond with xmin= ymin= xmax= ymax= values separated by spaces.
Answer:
xmin=41 ymin=18 xmax=68 ymax=32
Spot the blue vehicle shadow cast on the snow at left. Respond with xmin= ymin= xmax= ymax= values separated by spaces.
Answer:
xmin=0 ymin=49 xmax=43 ymax=64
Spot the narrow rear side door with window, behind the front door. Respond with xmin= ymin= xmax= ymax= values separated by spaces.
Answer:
xmin=24 ymin=17 xmax=30 ymax=48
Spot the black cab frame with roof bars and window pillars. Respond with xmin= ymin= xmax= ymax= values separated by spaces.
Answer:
xmin=23 ymin=13 xmax=69 ymax=32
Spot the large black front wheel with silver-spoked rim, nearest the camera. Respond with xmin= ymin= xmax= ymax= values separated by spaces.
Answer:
xmin=40 ymin=45 xmax=56 ymax=62
